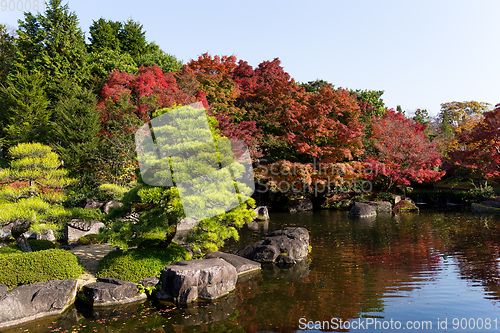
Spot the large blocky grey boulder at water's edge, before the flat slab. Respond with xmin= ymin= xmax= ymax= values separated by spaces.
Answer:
xmin=156 ymin=258 xmax=238 ymax=303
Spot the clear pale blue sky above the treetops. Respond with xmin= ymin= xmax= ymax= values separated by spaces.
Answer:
xmin=0 ymin=0 xmax=500 ymax=115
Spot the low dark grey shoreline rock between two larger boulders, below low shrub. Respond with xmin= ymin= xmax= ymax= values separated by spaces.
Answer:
xmin=81 ymin=278 xmax=146 ymax=306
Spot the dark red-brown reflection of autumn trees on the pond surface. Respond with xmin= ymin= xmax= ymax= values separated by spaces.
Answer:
xmin=186 ymin=212 xmax=500 ymax=332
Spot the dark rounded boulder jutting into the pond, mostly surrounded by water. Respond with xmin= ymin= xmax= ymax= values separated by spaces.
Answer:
xmin=235 ymin=227 xmax=309 ymax=264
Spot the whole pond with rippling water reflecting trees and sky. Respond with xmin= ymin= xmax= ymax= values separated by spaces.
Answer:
xmin=2 ymin=210 xmax=500 ymax=333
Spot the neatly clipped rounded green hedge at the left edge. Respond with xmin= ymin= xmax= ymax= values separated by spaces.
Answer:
xmin=0 ymin=249 xmax=85 ymax=288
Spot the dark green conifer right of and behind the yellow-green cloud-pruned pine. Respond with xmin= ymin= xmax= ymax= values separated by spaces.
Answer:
xmin=53 ymin=81 xmax=101 ymax=172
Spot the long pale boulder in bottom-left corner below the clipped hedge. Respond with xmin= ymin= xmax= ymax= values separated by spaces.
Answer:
xmin=0 ymin=280 xmax=77 ymax=328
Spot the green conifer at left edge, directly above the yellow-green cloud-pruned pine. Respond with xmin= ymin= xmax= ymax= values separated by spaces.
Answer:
xmin=0 ymin=70 xmax=52 ymax=148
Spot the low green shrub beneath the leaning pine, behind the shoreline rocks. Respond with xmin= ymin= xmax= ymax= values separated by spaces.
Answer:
xmin=97 ymin=243 xmax=190 ymax=282
